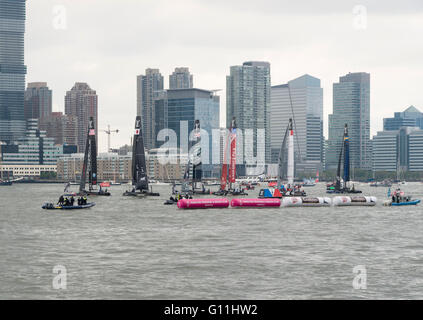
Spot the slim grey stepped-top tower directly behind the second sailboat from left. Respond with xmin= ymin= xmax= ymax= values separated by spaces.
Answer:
xmin=137 ymin=69 xmax=163 ymax=150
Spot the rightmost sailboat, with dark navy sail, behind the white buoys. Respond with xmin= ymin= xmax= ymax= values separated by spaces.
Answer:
xmin=326 ymin=124 xmax=361 ymax=193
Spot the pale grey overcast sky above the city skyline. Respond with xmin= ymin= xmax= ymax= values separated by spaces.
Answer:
xmin=25 ymin=0 xmax=423 ymax=151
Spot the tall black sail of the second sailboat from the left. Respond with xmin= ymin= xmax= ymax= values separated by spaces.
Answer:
xmin=132 ymin=116 xmax=148 ymax=190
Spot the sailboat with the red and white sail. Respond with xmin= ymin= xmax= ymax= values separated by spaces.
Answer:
xmin=213 ymin=117 xmax=248 ymax=196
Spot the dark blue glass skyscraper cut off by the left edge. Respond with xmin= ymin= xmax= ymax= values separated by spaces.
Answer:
xmin=0 ymin=0 xmax=26 ymax=142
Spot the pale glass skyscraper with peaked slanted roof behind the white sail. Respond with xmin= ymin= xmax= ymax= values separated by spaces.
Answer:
xmin=270 ymin=74 xmax=323 ymax=171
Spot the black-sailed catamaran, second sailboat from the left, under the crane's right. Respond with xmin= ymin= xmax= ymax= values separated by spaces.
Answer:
xmin=123 ymin=116 xmax=160 ymax=197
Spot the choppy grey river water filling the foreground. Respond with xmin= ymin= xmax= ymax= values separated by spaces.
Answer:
xmin=0 ymin=183 xmax=423 ymax=299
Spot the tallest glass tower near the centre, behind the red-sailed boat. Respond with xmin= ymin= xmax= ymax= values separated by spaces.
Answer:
xmin=226 ymin=61 xmax=270 ymax=174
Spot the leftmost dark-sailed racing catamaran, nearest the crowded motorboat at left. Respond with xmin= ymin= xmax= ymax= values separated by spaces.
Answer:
xmin=79 ymin=117 xmax=110 ymax=196
